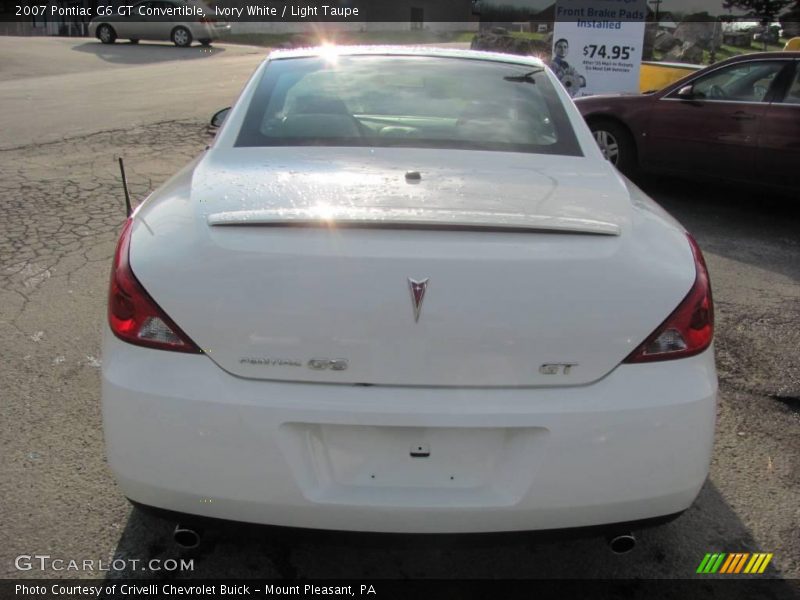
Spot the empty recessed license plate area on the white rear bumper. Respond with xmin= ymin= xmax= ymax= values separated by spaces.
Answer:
xmin=281 ymin=423 xmax=547 ymax=506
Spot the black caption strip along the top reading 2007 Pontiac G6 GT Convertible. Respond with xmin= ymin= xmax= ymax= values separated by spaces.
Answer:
xmin=0 ymin=0 xmax=800 ymax=23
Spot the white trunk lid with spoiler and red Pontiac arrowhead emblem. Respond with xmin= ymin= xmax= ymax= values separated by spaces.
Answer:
xmin=131 ymin=148 xmax=694 ymax=386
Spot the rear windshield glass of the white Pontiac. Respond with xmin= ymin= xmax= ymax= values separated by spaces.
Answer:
xmin=236 ymin=56 xmax=581 ymax=156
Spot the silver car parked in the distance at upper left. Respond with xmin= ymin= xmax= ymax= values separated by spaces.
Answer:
xmin=89 ymin=0 xmax=231 ymax=47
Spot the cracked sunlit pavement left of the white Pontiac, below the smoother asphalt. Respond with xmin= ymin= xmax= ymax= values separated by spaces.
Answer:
xmin=0 ymin=122 xmax=208 ymax=577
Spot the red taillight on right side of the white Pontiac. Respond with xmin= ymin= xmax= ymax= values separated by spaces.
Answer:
xmin=623 ymin=235 xmax=714 ymax=363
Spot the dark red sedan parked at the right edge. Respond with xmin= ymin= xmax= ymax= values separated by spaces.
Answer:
xmin=575 ymin=52 xmax=800 ymax=190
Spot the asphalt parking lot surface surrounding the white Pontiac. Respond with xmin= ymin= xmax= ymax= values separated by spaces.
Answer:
xmin=0 ymin=38 xmax=800 ymax=597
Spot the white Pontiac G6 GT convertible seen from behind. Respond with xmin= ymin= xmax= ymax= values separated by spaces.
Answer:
xmin=102 ymin=48 xmax=717 ymax=544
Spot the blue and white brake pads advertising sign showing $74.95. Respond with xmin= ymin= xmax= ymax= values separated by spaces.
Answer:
xmin=550 ymin=0 xmax=647 ymax=97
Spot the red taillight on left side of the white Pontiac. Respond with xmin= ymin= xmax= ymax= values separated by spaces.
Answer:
xmin=108 ymin=218 xmax=203 ymax=354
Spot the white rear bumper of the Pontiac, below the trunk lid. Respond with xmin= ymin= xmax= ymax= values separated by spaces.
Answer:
xmin=103 ymin=333 xmax=717 ymax=533
